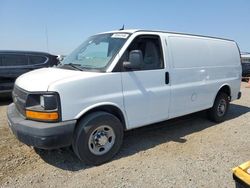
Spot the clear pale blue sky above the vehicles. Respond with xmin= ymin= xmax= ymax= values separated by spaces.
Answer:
xmin=0 ymin=0 xmax=250 ymax=55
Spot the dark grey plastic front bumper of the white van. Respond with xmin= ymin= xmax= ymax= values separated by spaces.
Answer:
xmin=7 ymin=103 xmax=76 ymax=149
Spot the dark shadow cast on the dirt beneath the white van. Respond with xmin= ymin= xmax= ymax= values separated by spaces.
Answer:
xmin=35 ymin=104 xmax=250 ymax=171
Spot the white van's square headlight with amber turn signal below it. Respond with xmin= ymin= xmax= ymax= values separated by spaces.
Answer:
xmin=26 ymin=93 xmax=60 ymax=122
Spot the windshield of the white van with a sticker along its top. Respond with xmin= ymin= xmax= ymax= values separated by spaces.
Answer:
xmin=62 ymin=33 xmax=129 ymax=70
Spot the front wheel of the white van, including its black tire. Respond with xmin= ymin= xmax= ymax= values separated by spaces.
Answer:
xmin=72 ymin=111 xmax=123 ymax=165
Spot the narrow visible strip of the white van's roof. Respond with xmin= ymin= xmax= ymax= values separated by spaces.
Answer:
xmin=101 ymin=29 xmax=235 ymax=42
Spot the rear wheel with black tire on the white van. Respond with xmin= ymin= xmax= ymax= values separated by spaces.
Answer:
xmin=208 ymin=92 xmax=230 ymax=123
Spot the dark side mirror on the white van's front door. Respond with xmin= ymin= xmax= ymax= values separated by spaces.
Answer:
xmin=123 ymin=50 xmax=143 ymax=70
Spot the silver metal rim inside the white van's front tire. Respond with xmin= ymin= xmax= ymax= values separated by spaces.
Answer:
xmin=88 ymin=125 xmax=115 ymax=155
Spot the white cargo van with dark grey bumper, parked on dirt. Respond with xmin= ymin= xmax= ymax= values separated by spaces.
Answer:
xmin=7 ymin=30 xmax=242 ymax=164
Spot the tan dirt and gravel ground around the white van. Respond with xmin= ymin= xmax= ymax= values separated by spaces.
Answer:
xmin=0 ymin=83 xmax=250 ymax=188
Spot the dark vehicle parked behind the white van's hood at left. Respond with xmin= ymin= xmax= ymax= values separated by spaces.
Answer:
xmin=0 ymin=50 xmax=59 ymax=93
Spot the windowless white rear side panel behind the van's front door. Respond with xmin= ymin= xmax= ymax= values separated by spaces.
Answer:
xmin=166 ymin=34 xmax=241 ymax=117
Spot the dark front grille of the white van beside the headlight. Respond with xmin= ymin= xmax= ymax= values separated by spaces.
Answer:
xmin=12 ymin=85 xmax=28 ymax=116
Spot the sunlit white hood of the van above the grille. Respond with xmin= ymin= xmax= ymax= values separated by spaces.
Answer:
xmin=15 ymin=68 xmax=87 ymax=91
